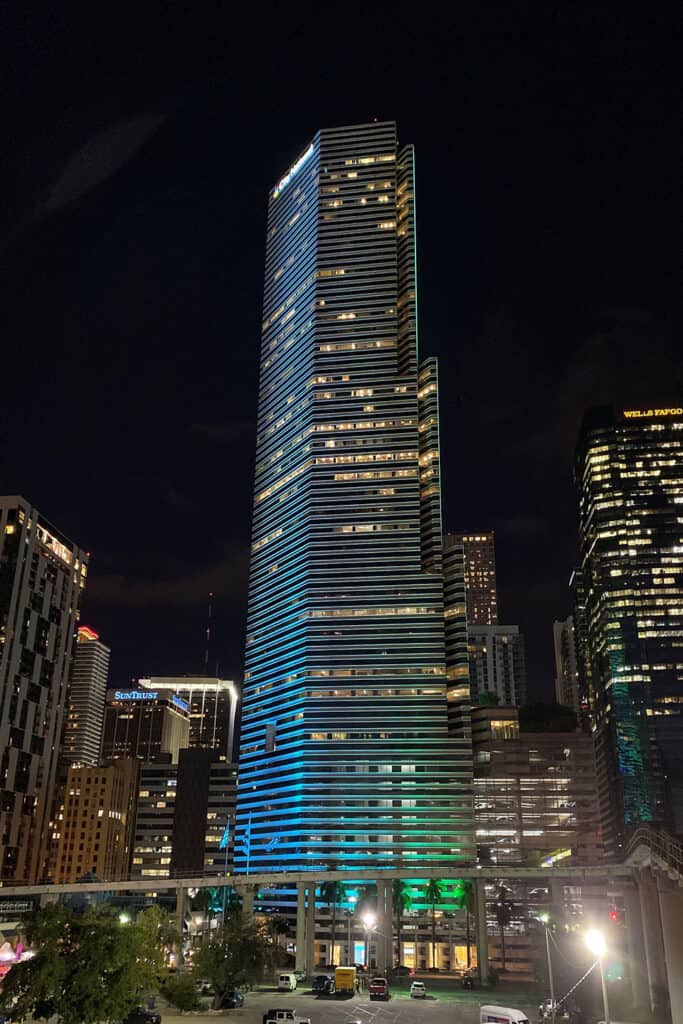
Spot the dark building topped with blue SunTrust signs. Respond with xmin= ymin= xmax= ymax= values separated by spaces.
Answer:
xmin=102 ymin=689 xmax=189 ymax=764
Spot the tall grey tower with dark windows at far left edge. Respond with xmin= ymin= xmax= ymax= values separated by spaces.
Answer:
xmin=0 ymin=496 xmax=88 ymax=883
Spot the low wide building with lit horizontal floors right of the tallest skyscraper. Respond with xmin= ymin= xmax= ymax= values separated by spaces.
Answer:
xmin=472 ymin=707 xmax=602 ymax=867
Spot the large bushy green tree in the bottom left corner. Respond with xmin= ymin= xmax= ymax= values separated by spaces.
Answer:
xmin=0 ymin=904 xmax=170 ymax=1024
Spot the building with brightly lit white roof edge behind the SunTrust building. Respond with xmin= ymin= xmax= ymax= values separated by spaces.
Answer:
xmin=137 ymin=676 xmax=238 ymax=762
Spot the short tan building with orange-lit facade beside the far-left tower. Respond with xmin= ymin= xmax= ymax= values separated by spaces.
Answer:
xmin=53 ymin=758 xmax=138 ymax=883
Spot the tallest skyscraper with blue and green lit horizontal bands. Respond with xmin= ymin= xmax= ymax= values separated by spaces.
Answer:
xmin=236 ymin=123 xmax=473 ymax=870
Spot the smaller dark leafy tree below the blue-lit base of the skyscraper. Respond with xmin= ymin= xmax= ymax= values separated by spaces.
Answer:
xmin=193 ymin=913 xmax=273 ymax=1010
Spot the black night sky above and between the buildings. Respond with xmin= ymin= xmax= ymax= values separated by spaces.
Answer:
xmin=0 ymin=2 xmax=681 ymax=695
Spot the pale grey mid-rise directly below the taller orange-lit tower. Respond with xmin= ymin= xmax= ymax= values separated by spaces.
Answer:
xmin=468 ymin=626 xmax=526 ymax=705
